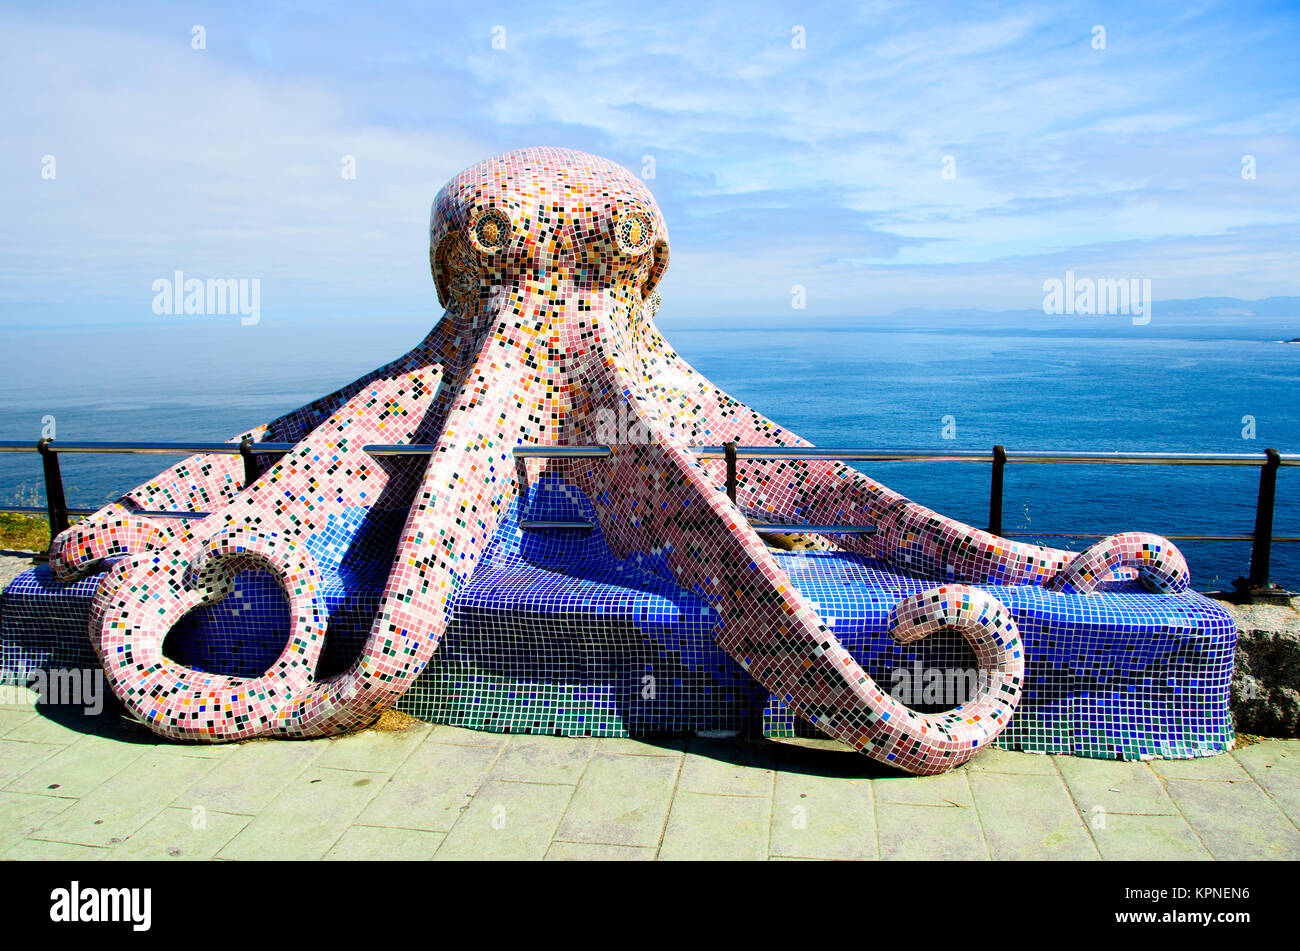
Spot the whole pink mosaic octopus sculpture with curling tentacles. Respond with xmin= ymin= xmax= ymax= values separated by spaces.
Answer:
xmin=30 ymin=148 xmax=1222 ymax=773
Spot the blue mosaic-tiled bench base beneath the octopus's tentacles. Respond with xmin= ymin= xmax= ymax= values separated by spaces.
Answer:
xmin=0 ymin=483 xmax=1236 ymax=759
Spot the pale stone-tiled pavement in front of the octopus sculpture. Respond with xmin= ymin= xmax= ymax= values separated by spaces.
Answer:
xmin=0 ymin=689 xmax=1300 ymax=860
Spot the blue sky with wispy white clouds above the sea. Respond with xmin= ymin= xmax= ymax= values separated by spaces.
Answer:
xmin=0 ymin=1 xmax=1300 ymax=330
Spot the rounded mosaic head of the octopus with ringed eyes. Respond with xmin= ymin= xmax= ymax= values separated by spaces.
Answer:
xmin=429 ymin=148 xmax=668 ymax=323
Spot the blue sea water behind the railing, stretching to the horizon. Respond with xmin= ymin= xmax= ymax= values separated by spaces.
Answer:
xmin=0 ymin=313 xmax=1300 ymax=590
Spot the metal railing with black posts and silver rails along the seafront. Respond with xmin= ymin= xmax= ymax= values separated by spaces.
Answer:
xmin=0 ymin=438 xmax=1300 ymax=595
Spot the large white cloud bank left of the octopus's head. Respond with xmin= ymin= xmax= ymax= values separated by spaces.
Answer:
xmin=0 ymin=12 xmax=493 ymax=308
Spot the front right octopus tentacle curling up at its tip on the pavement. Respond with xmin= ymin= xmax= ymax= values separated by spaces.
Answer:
xmin=564 ymin=299 xmax=1023 ymax=773
